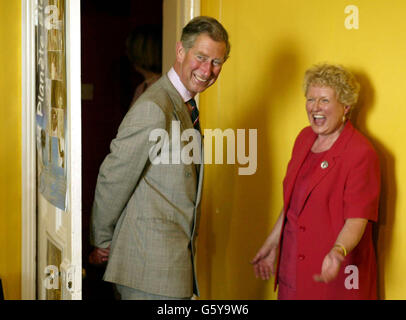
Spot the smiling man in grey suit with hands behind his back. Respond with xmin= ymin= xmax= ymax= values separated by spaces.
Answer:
xmin=90 ymin=17 xmax=230 ymax=300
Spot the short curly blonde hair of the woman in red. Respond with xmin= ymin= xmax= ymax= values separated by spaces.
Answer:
xmin=303 ymin=63 xmax=360 ymax=107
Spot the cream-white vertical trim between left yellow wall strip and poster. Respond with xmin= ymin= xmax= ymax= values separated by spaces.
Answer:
xmin=21 ymin=0 xmax=36 ymax=300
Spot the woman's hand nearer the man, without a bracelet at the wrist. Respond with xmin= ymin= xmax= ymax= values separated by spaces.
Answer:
xmin=251 ymin=244 xmax=278 ymax=280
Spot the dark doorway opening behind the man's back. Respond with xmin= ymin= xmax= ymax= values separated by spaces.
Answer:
xmin=81 ymin=0 xmax=163 ymax=300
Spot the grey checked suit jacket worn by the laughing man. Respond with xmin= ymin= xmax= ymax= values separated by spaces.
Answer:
xmin=92 ymin=75 xmax=203 ymax=297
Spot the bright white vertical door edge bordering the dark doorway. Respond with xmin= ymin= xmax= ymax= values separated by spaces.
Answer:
xmin=65 ymin=0 xmax=82 ymax=300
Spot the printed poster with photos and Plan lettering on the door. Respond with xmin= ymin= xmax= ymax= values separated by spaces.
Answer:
xmin=35 ymin=0 xmax=67 ymax=211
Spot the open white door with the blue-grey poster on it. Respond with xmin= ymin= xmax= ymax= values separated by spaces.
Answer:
xmin=22 ymin=0 xmax=82 ymax=300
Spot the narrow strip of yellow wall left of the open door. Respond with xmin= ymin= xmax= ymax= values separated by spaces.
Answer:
xmin=0 ymin=0 xmax=21 ymax=299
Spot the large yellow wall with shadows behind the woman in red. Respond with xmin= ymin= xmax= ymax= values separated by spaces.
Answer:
xmin=198 ymin=0 xmax=406 ymax=299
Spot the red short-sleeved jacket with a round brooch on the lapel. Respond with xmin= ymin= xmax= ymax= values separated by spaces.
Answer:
xmin=275 ymin=121 xmax=380 ymax=299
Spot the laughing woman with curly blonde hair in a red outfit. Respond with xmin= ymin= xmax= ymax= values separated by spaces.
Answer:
xmin=252 ymin=64 xmax=380 ymax=299
